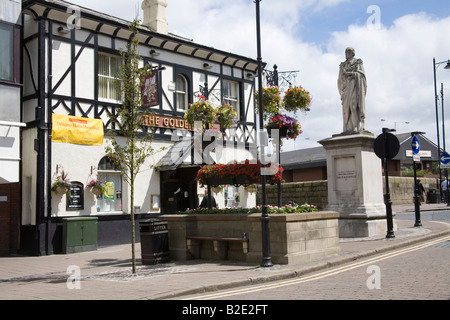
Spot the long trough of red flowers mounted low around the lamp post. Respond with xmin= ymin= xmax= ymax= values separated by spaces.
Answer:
xmin=196 ymin=160 xmax=283 ymax=186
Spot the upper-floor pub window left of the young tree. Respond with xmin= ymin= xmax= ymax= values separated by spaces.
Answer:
xmin=98 ymin=54 xmax=122 ymax=101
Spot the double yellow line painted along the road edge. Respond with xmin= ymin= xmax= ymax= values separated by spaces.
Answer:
xmin=180 ymin=236 xmax=450 ymax=300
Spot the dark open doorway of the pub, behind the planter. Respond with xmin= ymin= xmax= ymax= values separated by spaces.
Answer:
xmin=160 ymin=166 xmax=200 ymax=214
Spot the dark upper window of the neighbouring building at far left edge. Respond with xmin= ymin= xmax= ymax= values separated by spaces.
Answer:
xmin=0 ymin=24 xmax=14 ymax=81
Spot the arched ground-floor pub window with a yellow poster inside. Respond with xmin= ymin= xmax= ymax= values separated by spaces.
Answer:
xmin=97 ymin=157 xmax=122 ymax=213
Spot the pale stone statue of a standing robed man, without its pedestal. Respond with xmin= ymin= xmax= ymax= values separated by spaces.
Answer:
xmin=338 ymin=48 xmax=367 ymax=133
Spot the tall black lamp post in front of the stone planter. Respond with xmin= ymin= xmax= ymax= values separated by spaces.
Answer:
xmin=255 ymin=0 xmax=273 ymax=267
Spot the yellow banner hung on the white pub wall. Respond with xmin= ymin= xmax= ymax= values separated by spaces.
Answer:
xmin=52 ymin=113 xmax=104 ymax=146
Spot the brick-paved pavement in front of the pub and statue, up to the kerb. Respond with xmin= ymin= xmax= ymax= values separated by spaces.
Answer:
xmin=0 ymin=204 xmax=450 ymax=300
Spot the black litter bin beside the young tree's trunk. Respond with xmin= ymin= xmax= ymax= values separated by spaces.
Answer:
xmin=139 ymin=219 xmax=169 ymax=264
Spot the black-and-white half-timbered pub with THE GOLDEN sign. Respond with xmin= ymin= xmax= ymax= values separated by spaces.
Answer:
xmin=20 ymin=0 xmax=257 ymax=255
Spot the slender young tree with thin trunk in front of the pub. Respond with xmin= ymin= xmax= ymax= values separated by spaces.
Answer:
xmin=105 ymin=19 xmax=161 ymax=274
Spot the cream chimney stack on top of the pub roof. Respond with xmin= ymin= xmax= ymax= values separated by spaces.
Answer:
xmin=142 ymin=0 xmax=169 ymax=34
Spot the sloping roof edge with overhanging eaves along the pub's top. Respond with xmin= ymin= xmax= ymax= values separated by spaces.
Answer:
xmin=22 ymin=0 xmax=258 ymax=73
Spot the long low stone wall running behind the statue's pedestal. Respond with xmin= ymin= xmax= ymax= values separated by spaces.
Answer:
xmin=257 ymin=176 xmax=439 ymax=209
